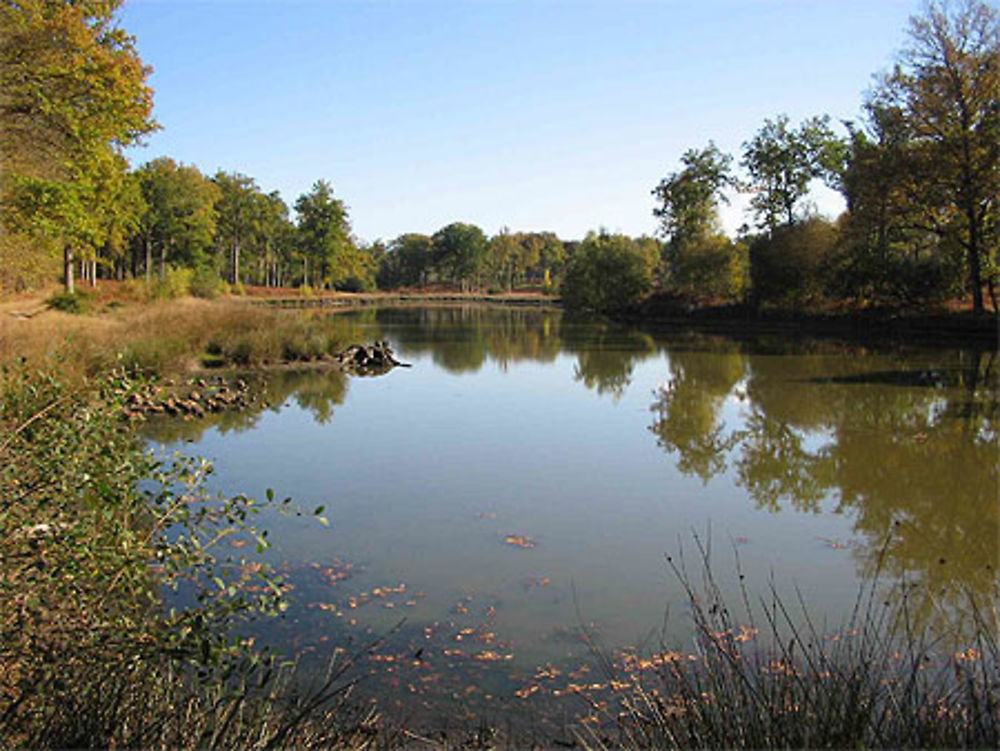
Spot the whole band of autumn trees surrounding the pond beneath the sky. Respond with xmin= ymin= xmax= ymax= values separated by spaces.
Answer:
xmin=0 ymin=0 xmax=1000 ymax=313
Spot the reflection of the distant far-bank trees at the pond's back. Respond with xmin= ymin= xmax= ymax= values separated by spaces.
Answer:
xmin=377 ymin=305 xmax=561 ymax=373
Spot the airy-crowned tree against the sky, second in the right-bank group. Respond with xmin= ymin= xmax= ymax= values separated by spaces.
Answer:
xmin=741 ymin=115 xmax=844 ymax=230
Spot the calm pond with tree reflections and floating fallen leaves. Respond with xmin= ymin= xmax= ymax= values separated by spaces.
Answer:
xmin=143 ymin=306 xmax=1000 ymax=728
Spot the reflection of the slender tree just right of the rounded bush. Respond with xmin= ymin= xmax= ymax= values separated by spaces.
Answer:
xmin=650 ymin=348 xmax=746 ymax=483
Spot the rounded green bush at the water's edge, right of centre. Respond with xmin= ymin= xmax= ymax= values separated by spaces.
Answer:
xmin=562 ymin=232 xmax=657 ymax=312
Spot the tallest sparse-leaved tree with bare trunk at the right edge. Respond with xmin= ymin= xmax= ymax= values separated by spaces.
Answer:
xmin=878 ymin=0 xmax=1000 ymax=313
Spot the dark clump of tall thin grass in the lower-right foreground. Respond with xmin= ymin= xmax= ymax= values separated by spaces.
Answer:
xmin=582 ymin=543 xmax=1000 ymax=748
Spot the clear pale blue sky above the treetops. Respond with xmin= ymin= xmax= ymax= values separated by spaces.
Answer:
xmin=121 ymin=0 xmax=920 ymax=240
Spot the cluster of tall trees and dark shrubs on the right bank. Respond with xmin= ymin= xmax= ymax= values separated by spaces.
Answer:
xmin=653 ymin=0 xmax=1000 ymax=312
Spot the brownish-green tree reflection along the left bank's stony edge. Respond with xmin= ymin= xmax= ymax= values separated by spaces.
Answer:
xmin=142 ymin=369 xmax=347 ymax=443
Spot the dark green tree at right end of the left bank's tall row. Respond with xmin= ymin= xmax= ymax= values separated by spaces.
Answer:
xmin=295 ymin=180 xmax=360 ymax=285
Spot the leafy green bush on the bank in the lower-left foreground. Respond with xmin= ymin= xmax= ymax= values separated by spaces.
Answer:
xmin=0 ymin=366 xmax=336 ymax=745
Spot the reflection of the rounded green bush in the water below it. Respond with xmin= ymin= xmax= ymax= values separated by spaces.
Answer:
xmin=562 ymin=320 xmax=659 ymax=399
